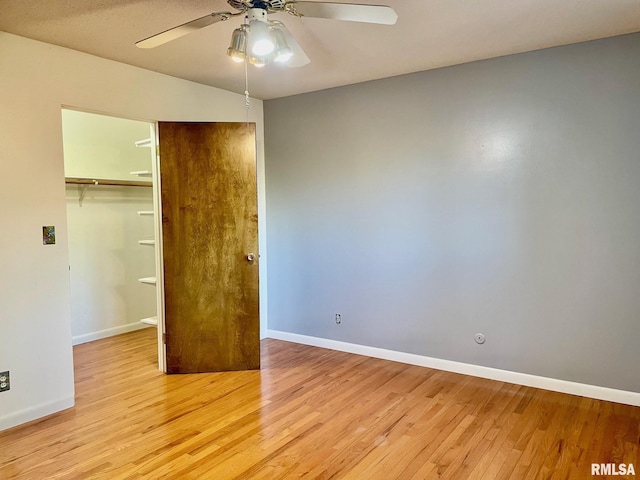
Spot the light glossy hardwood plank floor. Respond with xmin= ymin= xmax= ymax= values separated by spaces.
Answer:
xmin=0 ymin=329 xmax=640 ymax=480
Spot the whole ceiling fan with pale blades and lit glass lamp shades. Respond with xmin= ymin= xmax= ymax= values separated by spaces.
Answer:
xmin=136 ymin=0 xmax=398 ymax=67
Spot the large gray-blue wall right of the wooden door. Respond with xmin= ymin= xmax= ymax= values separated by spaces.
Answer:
xmin=264 ymin=34 xmax=640 ymax=392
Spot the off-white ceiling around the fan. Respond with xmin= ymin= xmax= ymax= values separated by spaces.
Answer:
xmin=0 ymin=0 xmax=640 ymax=99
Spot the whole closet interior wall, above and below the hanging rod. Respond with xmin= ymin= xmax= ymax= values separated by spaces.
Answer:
xmin=62 ymin=109 xmax=157 ymax=344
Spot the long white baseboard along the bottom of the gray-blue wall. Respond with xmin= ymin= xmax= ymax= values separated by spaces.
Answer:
xmin=267 ymin=330 xmax=640 ymax=406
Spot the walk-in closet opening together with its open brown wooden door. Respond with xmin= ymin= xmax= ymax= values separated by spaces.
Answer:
xmin=62 ymin=109 xmax=260 ymax=373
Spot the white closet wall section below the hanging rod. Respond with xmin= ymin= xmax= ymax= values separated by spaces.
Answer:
xmin=66 ymin=185 xmax=156 ymax=345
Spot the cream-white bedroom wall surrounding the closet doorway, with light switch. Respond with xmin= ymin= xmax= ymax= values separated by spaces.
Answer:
xmin=0 ymin=32 xmax=266 ymax=429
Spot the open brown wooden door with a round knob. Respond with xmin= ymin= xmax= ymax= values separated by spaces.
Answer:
xmin=158 ymin=122 xmax=260 ymax=373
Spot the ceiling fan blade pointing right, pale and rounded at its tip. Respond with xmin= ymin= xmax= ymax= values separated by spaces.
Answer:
xmin=285 ymin=1 xmax=398 ymax=25
